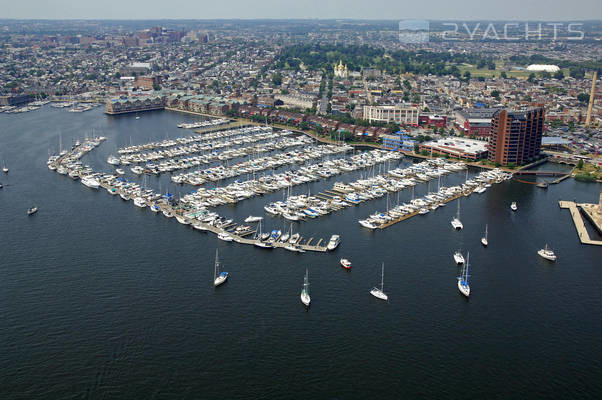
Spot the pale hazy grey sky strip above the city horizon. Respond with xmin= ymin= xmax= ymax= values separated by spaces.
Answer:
xmin=0 ymin=0 xmax=602 ymax=21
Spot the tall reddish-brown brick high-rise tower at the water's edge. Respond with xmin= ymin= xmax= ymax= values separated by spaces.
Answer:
xmin=489 ymin=108 xmax=545 ymax=165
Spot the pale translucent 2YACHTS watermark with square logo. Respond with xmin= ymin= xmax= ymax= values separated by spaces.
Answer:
xmin=399 ymin=19 xmax=585 ymax=43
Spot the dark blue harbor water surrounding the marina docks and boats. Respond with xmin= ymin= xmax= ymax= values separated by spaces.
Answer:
xmin=0 ymin=107 xmax=602 ymax=399
